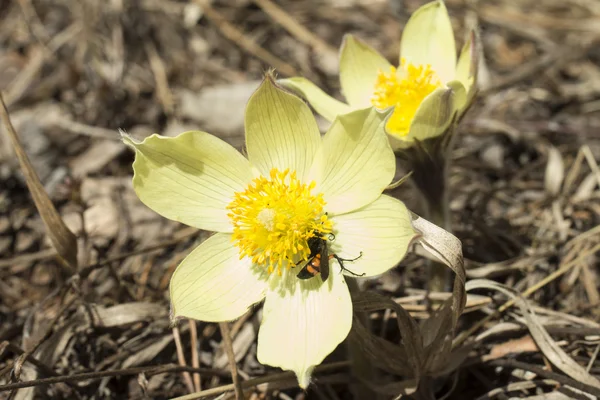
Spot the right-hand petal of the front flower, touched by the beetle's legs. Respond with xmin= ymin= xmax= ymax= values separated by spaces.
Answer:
xmin=330 ymin=195 xmax=417 ymax=276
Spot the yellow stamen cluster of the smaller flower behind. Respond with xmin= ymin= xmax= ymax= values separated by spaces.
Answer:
xmin=371 ymin=59 xmax=442 ymax=136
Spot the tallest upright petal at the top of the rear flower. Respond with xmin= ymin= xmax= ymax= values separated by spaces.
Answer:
xmin=400 ymin=0 xmax=456 ymax=83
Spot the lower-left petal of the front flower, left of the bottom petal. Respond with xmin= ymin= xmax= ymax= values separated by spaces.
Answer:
xmin=170 ymin=233 xmax=268 ymax=322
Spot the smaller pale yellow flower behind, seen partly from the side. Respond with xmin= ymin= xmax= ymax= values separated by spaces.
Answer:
xmin=281 ymin=0 xmax=477 ymax=148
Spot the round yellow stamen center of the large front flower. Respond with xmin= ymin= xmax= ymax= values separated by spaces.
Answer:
xmin=227 ymin=168 xmax=331 ymax=274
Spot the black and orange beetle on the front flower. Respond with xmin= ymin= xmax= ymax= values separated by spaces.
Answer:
xmin=296 ymin=233 xmax=365 ymax=282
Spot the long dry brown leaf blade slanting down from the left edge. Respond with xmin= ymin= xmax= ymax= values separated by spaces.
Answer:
xmin=0 ymin=95 xmax=77 ymax=271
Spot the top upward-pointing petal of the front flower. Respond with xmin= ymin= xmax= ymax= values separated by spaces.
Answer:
xmin=245 ymin=75 xmax=321 ymax=180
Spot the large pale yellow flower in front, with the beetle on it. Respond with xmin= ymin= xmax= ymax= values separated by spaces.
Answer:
xmin=124 ymin=76 xmax=416 ymax=387
